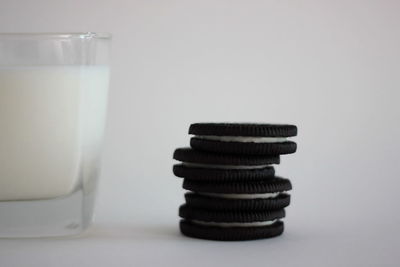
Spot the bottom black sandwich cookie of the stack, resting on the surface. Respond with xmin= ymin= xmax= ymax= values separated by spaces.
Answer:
xmin=179 ymin=204 xmax=285 ymax=240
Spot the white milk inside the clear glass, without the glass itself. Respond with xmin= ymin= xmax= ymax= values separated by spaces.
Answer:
xmin=0 ymin=66 xmax=109 ymax=201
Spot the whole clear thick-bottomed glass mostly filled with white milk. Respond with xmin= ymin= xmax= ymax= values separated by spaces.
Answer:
xmin=0 ymin=32 xmax=111 ymax=237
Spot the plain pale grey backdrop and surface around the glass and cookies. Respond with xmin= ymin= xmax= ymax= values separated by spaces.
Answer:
xmin=0 ymin=0 xmax=400 ymax=267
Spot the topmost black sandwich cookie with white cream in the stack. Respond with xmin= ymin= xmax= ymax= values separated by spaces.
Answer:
xmin=189 ymin=123 xmax=297 ymax=155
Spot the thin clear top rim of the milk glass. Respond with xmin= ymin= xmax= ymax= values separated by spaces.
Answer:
xmin=0 ymin=32 xmax=112 ymax=39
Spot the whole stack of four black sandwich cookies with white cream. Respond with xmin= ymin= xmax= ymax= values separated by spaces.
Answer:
xmin=173 ymin=123 xmax=297 ymax=241
